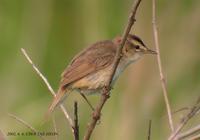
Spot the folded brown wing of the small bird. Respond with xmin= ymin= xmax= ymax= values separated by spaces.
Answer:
xmin=60 ymin=41 xmax=116 ymax=87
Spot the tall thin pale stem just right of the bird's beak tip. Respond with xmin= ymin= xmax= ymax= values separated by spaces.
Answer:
xmin=152 ymin=0 xmax=174 ymax=132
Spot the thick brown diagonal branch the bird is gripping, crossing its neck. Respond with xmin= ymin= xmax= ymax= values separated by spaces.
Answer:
xmin=83 ymin=0 xmax=141 ymax=140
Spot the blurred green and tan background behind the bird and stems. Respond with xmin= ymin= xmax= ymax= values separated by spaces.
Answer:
xmin=0 ymin=0 xmax=200 ymax=140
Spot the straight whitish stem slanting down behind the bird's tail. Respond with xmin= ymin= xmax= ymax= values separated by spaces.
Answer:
xmin=21 ymin=48 xmax=74 ymax=133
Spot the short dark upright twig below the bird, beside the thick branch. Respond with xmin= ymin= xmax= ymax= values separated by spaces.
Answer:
xmin=74 ymin=101 xmax=79 ymax=140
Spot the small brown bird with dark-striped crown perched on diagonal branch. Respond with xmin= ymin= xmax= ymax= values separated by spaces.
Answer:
xmin=48 ymin=34 xmax=156 ymax=114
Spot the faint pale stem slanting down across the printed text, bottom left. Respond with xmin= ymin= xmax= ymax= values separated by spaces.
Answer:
xmin=8 ymin=114 xmax=45 ymax=140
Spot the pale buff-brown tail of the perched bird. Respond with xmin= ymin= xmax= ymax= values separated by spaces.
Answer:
xmin=45 ymin=88 xmax=69 ymax=118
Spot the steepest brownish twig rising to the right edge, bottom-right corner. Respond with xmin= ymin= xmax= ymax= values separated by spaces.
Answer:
xmin=168 ymin=100 xmax=200 ymax=140
